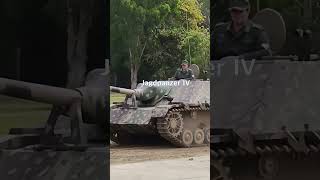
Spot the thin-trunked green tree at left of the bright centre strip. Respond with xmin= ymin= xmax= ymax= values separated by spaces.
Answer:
xmin=111 ymin=0 xmax=174 ymax=88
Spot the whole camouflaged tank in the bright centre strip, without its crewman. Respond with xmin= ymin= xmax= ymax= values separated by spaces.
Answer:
xmin=110 ymin=80 xmax=210 ymax=147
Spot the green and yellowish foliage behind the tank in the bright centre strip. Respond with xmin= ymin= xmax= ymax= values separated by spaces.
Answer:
xmin=111 ymin=0 xmax=210 ymax=86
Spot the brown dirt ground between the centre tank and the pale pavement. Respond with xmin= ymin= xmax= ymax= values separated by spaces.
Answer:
xmin=110 ymin=145 xmax=210 ymax=164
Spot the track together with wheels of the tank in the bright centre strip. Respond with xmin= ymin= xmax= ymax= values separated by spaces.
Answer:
xmin=157 ymin=106 xmax=210 ymax=147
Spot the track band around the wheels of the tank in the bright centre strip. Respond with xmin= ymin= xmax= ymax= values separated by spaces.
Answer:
xmin=157 ymin=106 xmax=210 ymax=147
